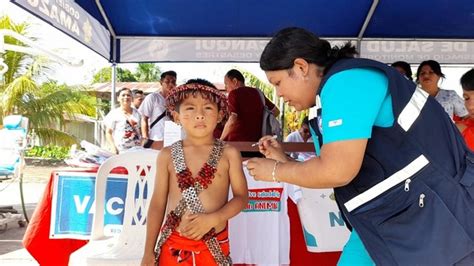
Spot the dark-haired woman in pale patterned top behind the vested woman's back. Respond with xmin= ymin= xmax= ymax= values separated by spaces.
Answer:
xmin=416 ymin=60 xmax=468 ymax=120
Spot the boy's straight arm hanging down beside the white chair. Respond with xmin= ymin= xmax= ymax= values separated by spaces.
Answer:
xmin=142 ymin=148 xmax=171 ymax=265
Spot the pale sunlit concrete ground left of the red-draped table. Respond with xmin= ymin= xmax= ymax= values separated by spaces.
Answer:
xmin=0 ymin=166 xmax=56 ymax=266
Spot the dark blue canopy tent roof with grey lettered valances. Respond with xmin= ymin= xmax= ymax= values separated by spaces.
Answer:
xmin=10 ymin=0 xmax=474 ymax=64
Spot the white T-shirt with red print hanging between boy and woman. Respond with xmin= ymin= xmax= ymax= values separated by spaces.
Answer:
xmin=229 ymin=167 xmax=301 ymax=265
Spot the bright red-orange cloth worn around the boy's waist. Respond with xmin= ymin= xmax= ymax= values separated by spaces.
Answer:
xmin=158 ymin=228 xmax=229 ymax=266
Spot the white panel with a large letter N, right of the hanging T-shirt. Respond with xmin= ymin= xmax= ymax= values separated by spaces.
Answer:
xmin=298 ymin=188 xmax=350 ymax=252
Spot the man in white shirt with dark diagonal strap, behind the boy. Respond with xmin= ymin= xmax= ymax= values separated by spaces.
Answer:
xmin=139 ymin=71 xmax=176 ymax=145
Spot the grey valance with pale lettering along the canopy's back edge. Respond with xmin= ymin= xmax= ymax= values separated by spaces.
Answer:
xmin=119 ymin=37 xmax=474 ymax=64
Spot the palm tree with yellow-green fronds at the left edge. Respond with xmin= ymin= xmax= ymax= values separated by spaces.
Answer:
xmin=0 ymin=16 xmax=95 ymax=145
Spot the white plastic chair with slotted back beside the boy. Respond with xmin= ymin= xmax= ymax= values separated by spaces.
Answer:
xmin=69 ymin=150 xmax=159 ymax=265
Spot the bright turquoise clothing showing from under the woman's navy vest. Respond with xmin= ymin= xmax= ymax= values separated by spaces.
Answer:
xmin=315 ymin=68 xmax=394 ymax=266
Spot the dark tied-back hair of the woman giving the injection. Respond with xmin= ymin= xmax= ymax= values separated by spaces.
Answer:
xmin=260 ymin=27 xmax=357 ymax=72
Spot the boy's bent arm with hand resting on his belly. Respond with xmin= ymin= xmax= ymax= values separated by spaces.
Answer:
xmin=181 ymin=145 xmax=248 ymax=240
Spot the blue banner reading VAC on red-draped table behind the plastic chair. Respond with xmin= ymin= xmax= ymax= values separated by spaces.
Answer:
xmin=50 ymin=172 xmax=127 ymax=239
